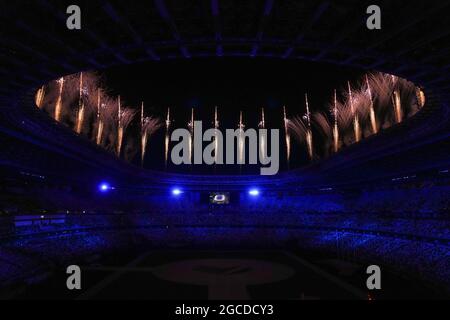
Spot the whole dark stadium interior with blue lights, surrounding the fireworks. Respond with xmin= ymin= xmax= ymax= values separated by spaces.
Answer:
xmin=0 ymin=0 xmax=450 ymax=300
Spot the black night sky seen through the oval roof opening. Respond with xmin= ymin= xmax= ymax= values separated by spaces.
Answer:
xmin=101 ymin=58 xmax=363 ymax=173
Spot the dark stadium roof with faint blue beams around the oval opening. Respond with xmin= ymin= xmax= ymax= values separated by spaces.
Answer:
xmin=0 ymin=0 xmax=450 ymax=188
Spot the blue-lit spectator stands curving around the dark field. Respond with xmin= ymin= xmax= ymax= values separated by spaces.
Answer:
xmin=0 ymin=171 xmax=450 ymax=289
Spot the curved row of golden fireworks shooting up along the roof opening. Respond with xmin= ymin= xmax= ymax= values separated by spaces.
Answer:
xmin=35 ymin=72 xmax=426 ymax=168
